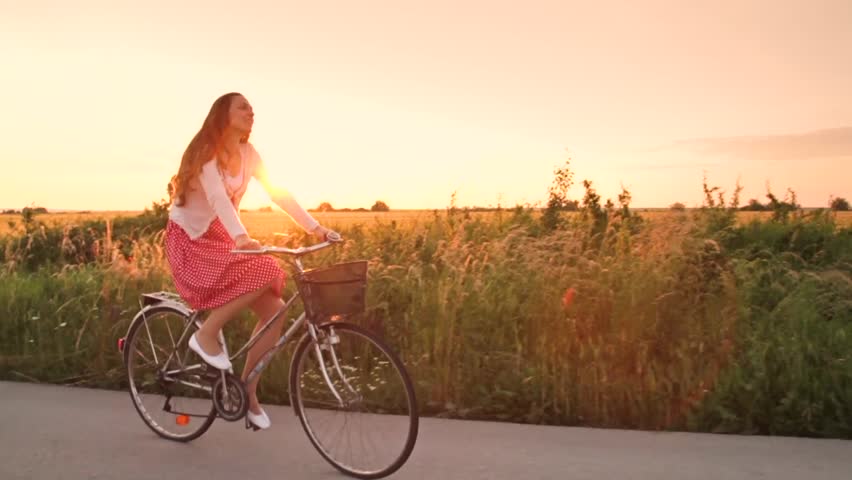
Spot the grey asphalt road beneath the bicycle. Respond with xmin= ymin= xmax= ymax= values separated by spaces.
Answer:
xmin=0 ymin=382 xmax=852 ymax=480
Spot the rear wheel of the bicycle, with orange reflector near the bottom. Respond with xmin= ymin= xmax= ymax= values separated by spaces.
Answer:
xmin=124 ymin=306 xmax=216 ymax=442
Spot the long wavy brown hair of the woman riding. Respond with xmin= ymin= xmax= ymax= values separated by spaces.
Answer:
xmin=168 ymin=92 xmax=248 ymax=205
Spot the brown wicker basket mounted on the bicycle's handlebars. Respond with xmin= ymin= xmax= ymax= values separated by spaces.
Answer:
xmin=296 ymin=261 xmax=367 ymax=318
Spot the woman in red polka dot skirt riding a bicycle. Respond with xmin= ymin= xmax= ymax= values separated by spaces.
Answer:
xmin=166 ymin=93 xmax=336 ymax=429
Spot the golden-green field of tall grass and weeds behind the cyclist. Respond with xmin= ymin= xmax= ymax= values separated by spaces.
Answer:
xmin=5 ymin=199 xmax=852 ymax=438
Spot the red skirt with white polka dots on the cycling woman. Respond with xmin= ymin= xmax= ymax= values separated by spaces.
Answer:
xmin=166 ymin=218 xmax=284 ymax=310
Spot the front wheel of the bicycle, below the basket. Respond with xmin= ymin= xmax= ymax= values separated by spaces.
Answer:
xmin=290 ymin=322 xmax=419 ymax=478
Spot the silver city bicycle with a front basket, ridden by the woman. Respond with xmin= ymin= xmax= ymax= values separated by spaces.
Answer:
xmin=118 ymin=241 xmax=419 ymax=478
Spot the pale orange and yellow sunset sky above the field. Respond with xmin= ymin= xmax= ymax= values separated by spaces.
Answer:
xmin=0 ymin=0 xmax=852 ymax=210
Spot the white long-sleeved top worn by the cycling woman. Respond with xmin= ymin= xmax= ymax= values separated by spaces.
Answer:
xmin=169 ymin=143 xmax=319 ymax=240
